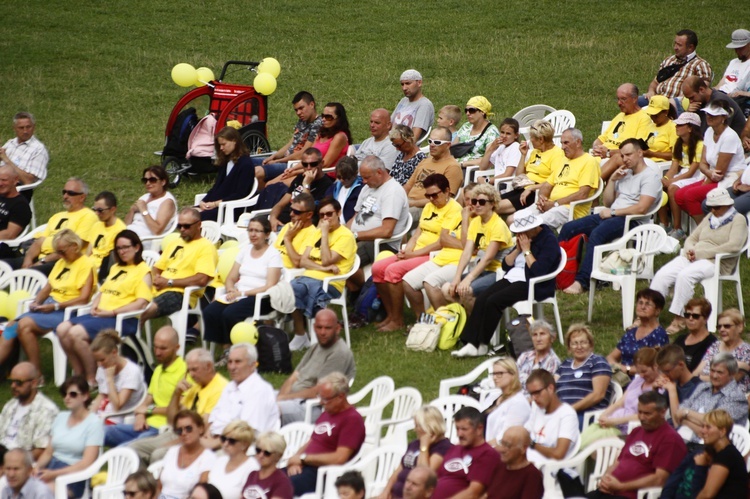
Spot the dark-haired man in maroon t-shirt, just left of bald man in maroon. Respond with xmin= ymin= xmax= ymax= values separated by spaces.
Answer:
xmin=432 ymin=407 xmax=500 ymax=499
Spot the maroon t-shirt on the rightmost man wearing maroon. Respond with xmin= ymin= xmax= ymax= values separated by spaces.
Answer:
xmin=612 ymin=423 xmax=687 ymax=499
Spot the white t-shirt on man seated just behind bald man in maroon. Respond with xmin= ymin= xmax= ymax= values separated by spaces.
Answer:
xmin=524 ymin=403 xmax=581 ymax=468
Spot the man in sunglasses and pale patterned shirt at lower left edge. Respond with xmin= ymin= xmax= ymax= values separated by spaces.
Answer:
xmin=0 ymin=362 xmax=58 ymax=459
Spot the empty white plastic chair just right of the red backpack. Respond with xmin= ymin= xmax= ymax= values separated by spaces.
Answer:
xmin=588 ymin=224 xmax=668 ymax=329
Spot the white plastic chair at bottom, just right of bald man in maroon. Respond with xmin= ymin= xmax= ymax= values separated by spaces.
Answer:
xmin=541 ymin=438 xmax=625 ymax=497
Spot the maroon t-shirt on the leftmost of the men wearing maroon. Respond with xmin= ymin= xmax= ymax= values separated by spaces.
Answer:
xmin=305 ymin=407 xmax=365 ymax=457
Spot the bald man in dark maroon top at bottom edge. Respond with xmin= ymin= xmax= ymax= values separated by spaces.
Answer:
xmin=487 ymin=426 xmax=544 ymax=499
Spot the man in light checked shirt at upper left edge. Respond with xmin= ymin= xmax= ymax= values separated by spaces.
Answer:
xmin=0 ymin=113 xmax=49 ymax=188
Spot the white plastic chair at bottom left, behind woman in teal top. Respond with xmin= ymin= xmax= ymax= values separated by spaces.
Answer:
xmin=55 ymin=447 xmax=140 ymax=499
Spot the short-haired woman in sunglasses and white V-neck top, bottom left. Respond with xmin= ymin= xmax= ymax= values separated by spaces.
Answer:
xmin=159 ymin=409 xmax=216 ymax=499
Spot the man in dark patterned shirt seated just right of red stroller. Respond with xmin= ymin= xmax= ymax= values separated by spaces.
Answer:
xmin=251 ymin=91 xmax=323 ymax=191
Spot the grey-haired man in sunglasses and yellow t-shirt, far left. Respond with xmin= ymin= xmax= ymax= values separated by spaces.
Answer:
xmin=6 ymin=177 xmax=99 ymax=275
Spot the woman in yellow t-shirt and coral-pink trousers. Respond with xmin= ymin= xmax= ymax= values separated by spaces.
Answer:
xmin=372 ymin=173 xmax=461 ymax=331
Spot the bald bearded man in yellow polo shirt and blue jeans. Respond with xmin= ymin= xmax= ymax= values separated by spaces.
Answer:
xmin=104 ymin=326 xmax=187 ymax=447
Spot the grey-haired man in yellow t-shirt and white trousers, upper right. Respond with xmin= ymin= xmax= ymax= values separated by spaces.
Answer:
xmin=507 ymin=128 xmax=601 ymax=230
